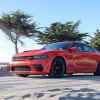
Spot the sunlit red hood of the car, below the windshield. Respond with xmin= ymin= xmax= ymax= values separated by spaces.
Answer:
xmin=15 ymin=50 xmax=49 ymax=56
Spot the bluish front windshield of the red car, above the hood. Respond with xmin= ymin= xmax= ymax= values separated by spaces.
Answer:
xmin=42 ymin=42 xmax=70 ymax=50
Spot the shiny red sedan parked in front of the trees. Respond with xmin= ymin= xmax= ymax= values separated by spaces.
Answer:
xmin=10 ymin=41 xmax=100 ymax=77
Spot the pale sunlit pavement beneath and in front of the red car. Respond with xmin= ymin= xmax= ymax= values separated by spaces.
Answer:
xmin=0 ymin=75 xmax=100 ymax=100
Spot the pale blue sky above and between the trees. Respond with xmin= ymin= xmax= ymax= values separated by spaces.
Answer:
xmin=0 ymin=0 xmax=100 ymax=62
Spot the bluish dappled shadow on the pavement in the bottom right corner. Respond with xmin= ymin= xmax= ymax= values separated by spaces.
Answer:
xmin=59 ymin=88 xmax=100 ymax=100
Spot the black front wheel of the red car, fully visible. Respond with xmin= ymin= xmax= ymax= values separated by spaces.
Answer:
xmin=49 ymin=58 xmax=66 ymax=78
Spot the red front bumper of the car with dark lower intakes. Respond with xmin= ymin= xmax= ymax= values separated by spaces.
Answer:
xmin=10 ymin=60 xmax=50 ymax=75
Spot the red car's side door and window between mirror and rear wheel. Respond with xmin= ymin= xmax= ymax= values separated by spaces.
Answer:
xmin=74 ymin=43 xmax=97 ymax=73
